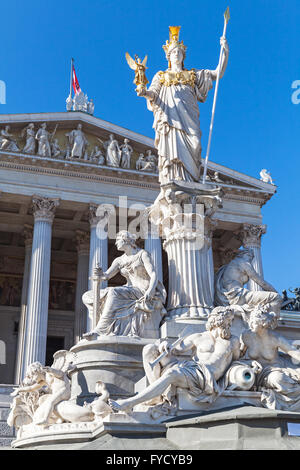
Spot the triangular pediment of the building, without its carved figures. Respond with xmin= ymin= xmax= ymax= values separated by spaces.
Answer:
xmin=0 ymin=111 xmax=276 ymax=200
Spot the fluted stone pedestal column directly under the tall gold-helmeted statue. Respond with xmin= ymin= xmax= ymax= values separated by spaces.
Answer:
xmin=151 ymin=182 xmax=222 ymax=319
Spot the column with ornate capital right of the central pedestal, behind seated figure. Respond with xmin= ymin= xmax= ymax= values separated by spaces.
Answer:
xmin=241 ymin=224 xmax=267 ymax=291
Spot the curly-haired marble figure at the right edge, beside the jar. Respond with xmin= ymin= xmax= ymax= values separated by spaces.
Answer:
xmin=242 ymin=307 xmax=300 ymax=412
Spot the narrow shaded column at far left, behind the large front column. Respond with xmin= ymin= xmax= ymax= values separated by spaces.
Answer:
xmin=15 ymin=225 xmax=33 ymax=384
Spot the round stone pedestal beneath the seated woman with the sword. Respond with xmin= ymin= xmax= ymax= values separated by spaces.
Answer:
xmin=70 ymin=336 xmax=153 ymax=405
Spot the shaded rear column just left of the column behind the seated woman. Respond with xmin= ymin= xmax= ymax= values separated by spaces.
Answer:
xmin=74 ymin=230 xmax=90 ymax=344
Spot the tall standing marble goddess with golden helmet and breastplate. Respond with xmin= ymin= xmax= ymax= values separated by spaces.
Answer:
xmin=137 ymin=27 xmax=229 ymax=184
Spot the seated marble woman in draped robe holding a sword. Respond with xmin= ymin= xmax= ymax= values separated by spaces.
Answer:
xmin=82 ymin=230 xmax=166 ymax=340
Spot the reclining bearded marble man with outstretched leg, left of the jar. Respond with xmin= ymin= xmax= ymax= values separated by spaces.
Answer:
xmin=109 ymin=308 xmax=240 ymax=411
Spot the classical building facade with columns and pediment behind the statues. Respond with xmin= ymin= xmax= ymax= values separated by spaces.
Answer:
xmin=0 ymin=111 xmax=298 ymax=392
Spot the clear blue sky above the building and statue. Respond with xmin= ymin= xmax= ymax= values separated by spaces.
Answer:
xmin=0 ymin=0 xmax=300 ymax=291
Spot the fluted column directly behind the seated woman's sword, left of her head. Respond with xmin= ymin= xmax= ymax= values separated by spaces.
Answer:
xmin=87 ymin=204 xmax=108 ymax=331
